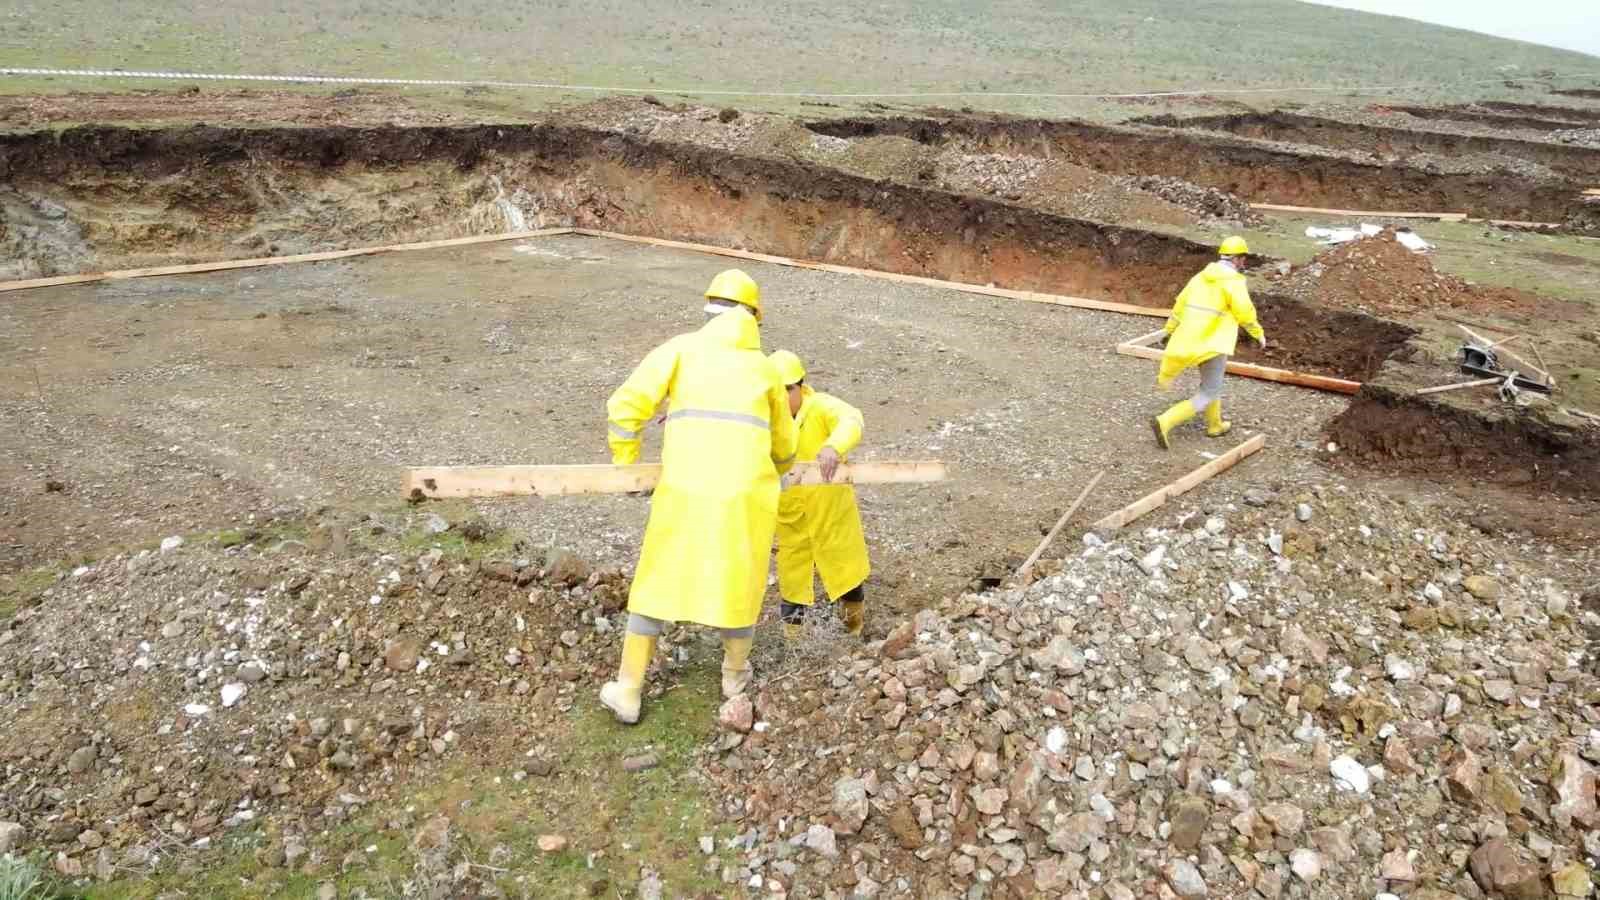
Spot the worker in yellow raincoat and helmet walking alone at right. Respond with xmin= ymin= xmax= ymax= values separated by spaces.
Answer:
xmin=1150 ymin=237 xmax=1267 ymax=448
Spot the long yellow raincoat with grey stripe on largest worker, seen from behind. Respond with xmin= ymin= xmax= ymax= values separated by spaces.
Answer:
xmin=606 ymin=309 xmax=795 ymax=628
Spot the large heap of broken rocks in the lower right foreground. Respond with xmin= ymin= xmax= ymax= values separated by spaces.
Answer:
xmin=706 ymin=485 xmax=1600 ymax=900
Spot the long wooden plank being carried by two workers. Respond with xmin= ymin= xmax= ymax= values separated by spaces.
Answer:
xmin=400 ymin=461 xmax=949 ymax=500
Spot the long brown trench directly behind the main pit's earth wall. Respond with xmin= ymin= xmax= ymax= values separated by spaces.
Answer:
xmin=806 ymin=112 xmax=1582 ymax=223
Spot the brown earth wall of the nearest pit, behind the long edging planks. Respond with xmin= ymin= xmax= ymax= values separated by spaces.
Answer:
xmin=0 ymin=125 xmax=1211 ymax=306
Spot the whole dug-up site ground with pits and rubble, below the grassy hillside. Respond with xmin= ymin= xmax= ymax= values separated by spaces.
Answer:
xmin=0 ymin=76 xmax=1600 ymax=900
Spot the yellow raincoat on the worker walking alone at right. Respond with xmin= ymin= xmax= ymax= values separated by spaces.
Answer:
xmin=1155 ymin=263 xmax=1262 ymax=386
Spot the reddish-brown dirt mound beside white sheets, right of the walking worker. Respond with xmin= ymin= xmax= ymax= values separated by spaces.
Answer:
xmin=1269 ymin=227 xmax=1550 ymax=317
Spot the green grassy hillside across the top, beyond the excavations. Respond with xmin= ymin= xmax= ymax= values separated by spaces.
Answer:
xmin=0 ymin=0 xmax=1600 ymax=112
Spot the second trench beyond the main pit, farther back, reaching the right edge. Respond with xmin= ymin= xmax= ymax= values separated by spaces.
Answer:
xmin=1134 ymin=112 xmax=1600 ymax=186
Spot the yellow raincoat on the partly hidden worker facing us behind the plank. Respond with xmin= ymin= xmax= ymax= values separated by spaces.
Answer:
xmin=778 ymin=386 xmax=872 ymax=605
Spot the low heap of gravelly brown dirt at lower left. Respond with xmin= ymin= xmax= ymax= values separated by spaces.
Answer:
xmin=0 ymin=524 xmax=633 ymax=878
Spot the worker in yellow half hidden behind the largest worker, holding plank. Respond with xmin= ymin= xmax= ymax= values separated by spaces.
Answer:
xmin=771 ymin=351 xmax=872 ymax=639
